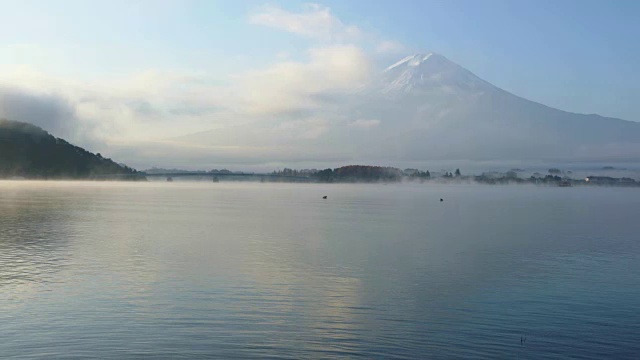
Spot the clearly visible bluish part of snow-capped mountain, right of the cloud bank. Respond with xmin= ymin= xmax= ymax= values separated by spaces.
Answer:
xmin=356 ymin=53 xmax=640 ymax=162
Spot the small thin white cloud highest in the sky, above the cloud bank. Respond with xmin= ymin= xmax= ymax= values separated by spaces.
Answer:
xmin=249 ymin=4 xmax=362 ymax=41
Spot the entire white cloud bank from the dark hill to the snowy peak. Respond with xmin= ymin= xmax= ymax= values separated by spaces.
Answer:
xmin=0 ymin=4 xmax=410 ymax=167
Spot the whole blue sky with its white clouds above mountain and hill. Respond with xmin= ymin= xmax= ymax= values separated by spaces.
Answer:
xmin=0 ymin=0 xmax=640 ymax=169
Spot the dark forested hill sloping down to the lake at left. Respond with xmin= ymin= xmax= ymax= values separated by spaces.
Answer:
xmin=0 ymin=119 xmax=145 ymax=180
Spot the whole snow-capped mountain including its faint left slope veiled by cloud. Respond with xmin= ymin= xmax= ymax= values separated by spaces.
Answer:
xmin=181 ymin=53 xmax=640 ymax=166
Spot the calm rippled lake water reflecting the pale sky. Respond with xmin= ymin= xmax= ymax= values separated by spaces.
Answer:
xmin=0 ymin=182 xmax=640 ymax=359
